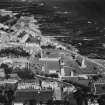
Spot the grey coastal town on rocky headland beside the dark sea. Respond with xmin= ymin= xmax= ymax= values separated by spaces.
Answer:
xmin=0 ymin=10 xmax=105 ymax=105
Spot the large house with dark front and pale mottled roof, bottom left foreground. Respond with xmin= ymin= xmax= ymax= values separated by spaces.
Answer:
xmin=13 ymin=80 xmax=53 ymax=104
